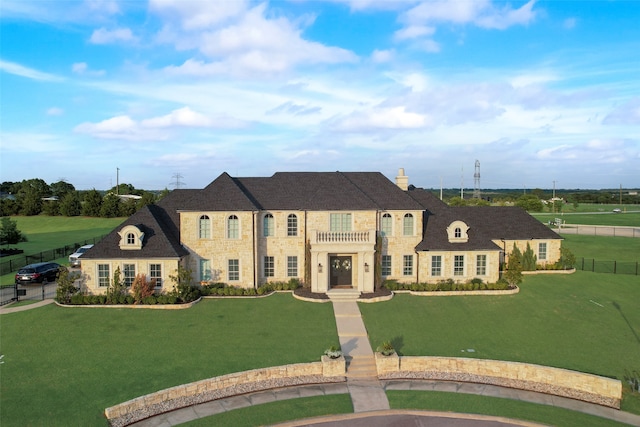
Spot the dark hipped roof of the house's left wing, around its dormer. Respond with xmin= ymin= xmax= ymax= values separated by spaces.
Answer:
xmin=82 ymin=205 xmax=188 ymax=259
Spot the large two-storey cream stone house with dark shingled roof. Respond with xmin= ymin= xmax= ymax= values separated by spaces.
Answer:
xmin=82 ymin=169 xmax=562 ymax=293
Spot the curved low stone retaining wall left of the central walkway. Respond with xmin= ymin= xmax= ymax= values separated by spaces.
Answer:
xmin=104 ymin=359 xmax=346 ymax=427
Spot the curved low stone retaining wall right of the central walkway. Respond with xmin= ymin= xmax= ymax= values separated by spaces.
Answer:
xmin=376 ymin=354 xmax=622 ymax=409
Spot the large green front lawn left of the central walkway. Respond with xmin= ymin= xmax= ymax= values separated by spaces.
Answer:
xmin=0 ymin=294 xmax=338 ymax=427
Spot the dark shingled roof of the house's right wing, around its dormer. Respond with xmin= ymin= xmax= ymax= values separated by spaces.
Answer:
xmin=416 ymin=206 xmax=562 ymax=251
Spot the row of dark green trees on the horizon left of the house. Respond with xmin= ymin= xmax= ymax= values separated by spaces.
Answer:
xmin=0 ymin=178 xmax=169 ymax=218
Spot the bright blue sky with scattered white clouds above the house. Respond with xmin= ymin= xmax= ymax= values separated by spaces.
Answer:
xmin=0 ymin=0 xmax=640 ymax=189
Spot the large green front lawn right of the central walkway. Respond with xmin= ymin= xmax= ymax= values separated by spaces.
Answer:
xmin=360 ymin=271 xmax=640 ymax=413
